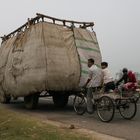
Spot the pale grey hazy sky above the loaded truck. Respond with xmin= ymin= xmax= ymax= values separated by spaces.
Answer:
xmin=0 ymin=0 xmax=140 ymax=76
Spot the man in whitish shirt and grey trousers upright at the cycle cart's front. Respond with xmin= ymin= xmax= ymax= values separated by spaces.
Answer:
xmin=84 ymin=58 xmax=102 ymax=113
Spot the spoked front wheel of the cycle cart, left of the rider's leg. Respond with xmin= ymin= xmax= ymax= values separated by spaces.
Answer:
xmin=73 ymin=94 xmax=87 ymax=115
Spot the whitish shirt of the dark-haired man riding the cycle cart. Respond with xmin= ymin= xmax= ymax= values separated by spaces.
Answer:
xmin=88 ymin=65 xmax=102 ymax=87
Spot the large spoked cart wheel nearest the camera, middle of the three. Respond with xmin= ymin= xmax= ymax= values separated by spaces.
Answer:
xmin=97 ymin=96 xmax=115 ymax=122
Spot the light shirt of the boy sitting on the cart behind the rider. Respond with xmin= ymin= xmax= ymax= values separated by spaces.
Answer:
xmin=102 ymin=68 xmax=113 ymax=84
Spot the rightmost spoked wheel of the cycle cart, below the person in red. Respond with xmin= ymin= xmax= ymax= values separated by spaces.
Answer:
xmin=119 ymin=99 xmax=137 ymax=120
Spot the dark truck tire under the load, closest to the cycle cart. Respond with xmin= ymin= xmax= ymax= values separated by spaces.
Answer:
xmin=53 ymin=94 xmax=69 ymax=108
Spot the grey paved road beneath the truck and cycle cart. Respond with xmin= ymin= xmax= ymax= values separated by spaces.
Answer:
xmin=1 ymin=97 xmax=140 ymax=140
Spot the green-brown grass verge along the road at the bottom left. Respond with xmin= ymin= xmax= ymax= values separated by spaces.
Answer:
xmin=0 ymin=104 xmax=90 ymax=140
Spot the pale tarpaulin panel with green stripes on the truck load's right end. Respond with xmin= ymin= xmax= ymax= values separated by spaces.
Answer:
xmin=74 ymin=28 xmax=101 ymax=86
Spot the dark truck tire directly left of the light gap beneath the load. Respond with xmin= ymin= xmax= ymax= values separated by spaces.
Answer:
xmin=24 ymin=94 xmax=39 ymax=109
